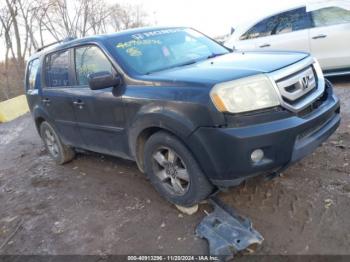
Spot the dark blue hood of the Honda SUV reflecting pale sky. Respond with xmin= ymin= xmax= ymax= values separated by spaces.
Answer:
xmin=142 ymin=52 xmax=308 ymax=85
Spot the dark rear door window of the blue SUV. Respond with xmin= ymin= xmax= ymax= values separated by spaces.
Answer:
xmin=45 ymin=50 xmax=71 ymax=87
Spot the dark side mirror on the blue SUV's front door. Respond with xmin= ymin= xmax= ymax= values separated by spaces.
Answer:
xmin=88 ymin=71 xmax=121 ymax=90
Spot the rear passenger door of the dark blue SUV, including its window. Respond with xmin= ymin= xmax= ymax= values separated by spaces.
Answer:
xmin=41 ymin=49 xmax=82 ymax=147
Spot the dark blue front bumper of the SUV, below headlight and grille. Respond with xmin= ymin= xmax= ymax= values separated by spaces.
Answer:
xmin=188 ymin=81 xmax=341 ymax=188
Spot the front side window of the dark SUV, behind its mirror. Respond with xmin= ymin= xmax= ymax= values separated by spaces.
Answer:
xmin=75 ymin=46 xmax=113 ymax=85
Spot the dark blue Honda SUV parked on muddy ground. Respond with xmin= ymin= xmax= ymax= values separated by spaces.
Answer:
xmin=26 ymin=28 xmax=340 ymax=206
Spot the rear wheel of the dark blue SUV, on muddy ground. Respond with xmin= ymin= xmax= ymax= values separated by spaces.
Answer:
xmin=40 ymin=121 xmax=75 ymax=165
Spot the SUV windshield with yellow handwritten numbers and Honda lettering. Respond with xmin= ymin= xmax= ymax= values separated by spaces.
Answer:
xmin=112 ymin=28 xmax=229 ymax=75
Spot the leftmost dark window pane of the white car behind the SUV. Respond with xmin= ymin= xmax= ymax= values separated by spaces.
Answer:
xmin=240 ymin=16 xmax=278 ymax=40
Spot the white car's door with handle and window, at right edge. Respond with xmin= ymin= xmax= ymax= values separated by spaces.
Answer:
xmin=310 ymin=7 xmax=350 ymax=70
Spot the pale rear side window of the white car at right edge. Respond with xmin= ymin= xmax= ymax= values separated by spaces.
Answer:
xmin=311 ymin=7 xmax=350 ymax=27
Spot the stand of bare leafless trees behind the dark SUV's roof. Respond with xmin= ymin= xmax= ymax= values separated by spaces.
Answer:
xmin=0 ymin=0 xmax=147 ymax=100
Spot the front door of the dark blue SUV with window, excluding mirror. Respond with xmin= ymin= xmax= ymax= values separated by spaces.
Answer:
xmin=73 ymin=45 xmax=128 ymax=157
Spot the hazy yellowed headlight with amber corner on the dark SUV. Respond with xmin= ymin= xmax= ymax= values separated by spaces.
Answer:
xmin=210 ymin=74 xmax=280 ymax=113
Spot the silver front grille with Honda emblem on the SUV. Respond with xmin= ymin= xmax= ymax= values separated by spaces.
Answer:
xmin=271 ymin=57 xmax=325 ymax=112
